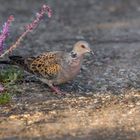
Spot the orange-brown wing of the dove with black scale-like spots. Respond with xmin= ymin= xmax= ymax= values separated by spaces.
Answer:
xmin=26 ymin=52 xmax=63 ymax=79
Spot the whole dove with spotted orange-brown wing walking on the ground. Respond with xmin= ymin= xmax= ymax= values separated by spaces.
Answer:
xmin=0 ymin=40 xmax=94 ymax=94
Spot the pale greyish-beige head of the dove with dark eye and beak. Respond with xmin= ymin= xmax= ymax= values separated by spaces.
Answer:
xmin=72 ymin=41 xmax=94 ymax=56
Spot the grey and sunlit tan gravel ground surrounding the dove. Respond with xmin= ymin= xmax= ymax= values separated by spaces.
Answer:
xmin=0 ymin=0 xmax=140 ymax=140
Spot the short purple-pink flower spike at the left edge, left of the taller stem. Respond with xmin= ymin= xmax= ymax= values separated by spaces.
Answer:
xmin=0 ymin=15 xmax=14 ymax=53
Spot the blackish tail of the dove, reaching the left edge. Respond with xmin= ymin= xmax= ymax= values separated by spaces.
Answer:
xmin=0 ymin=56 xmax=24 ymax=66
